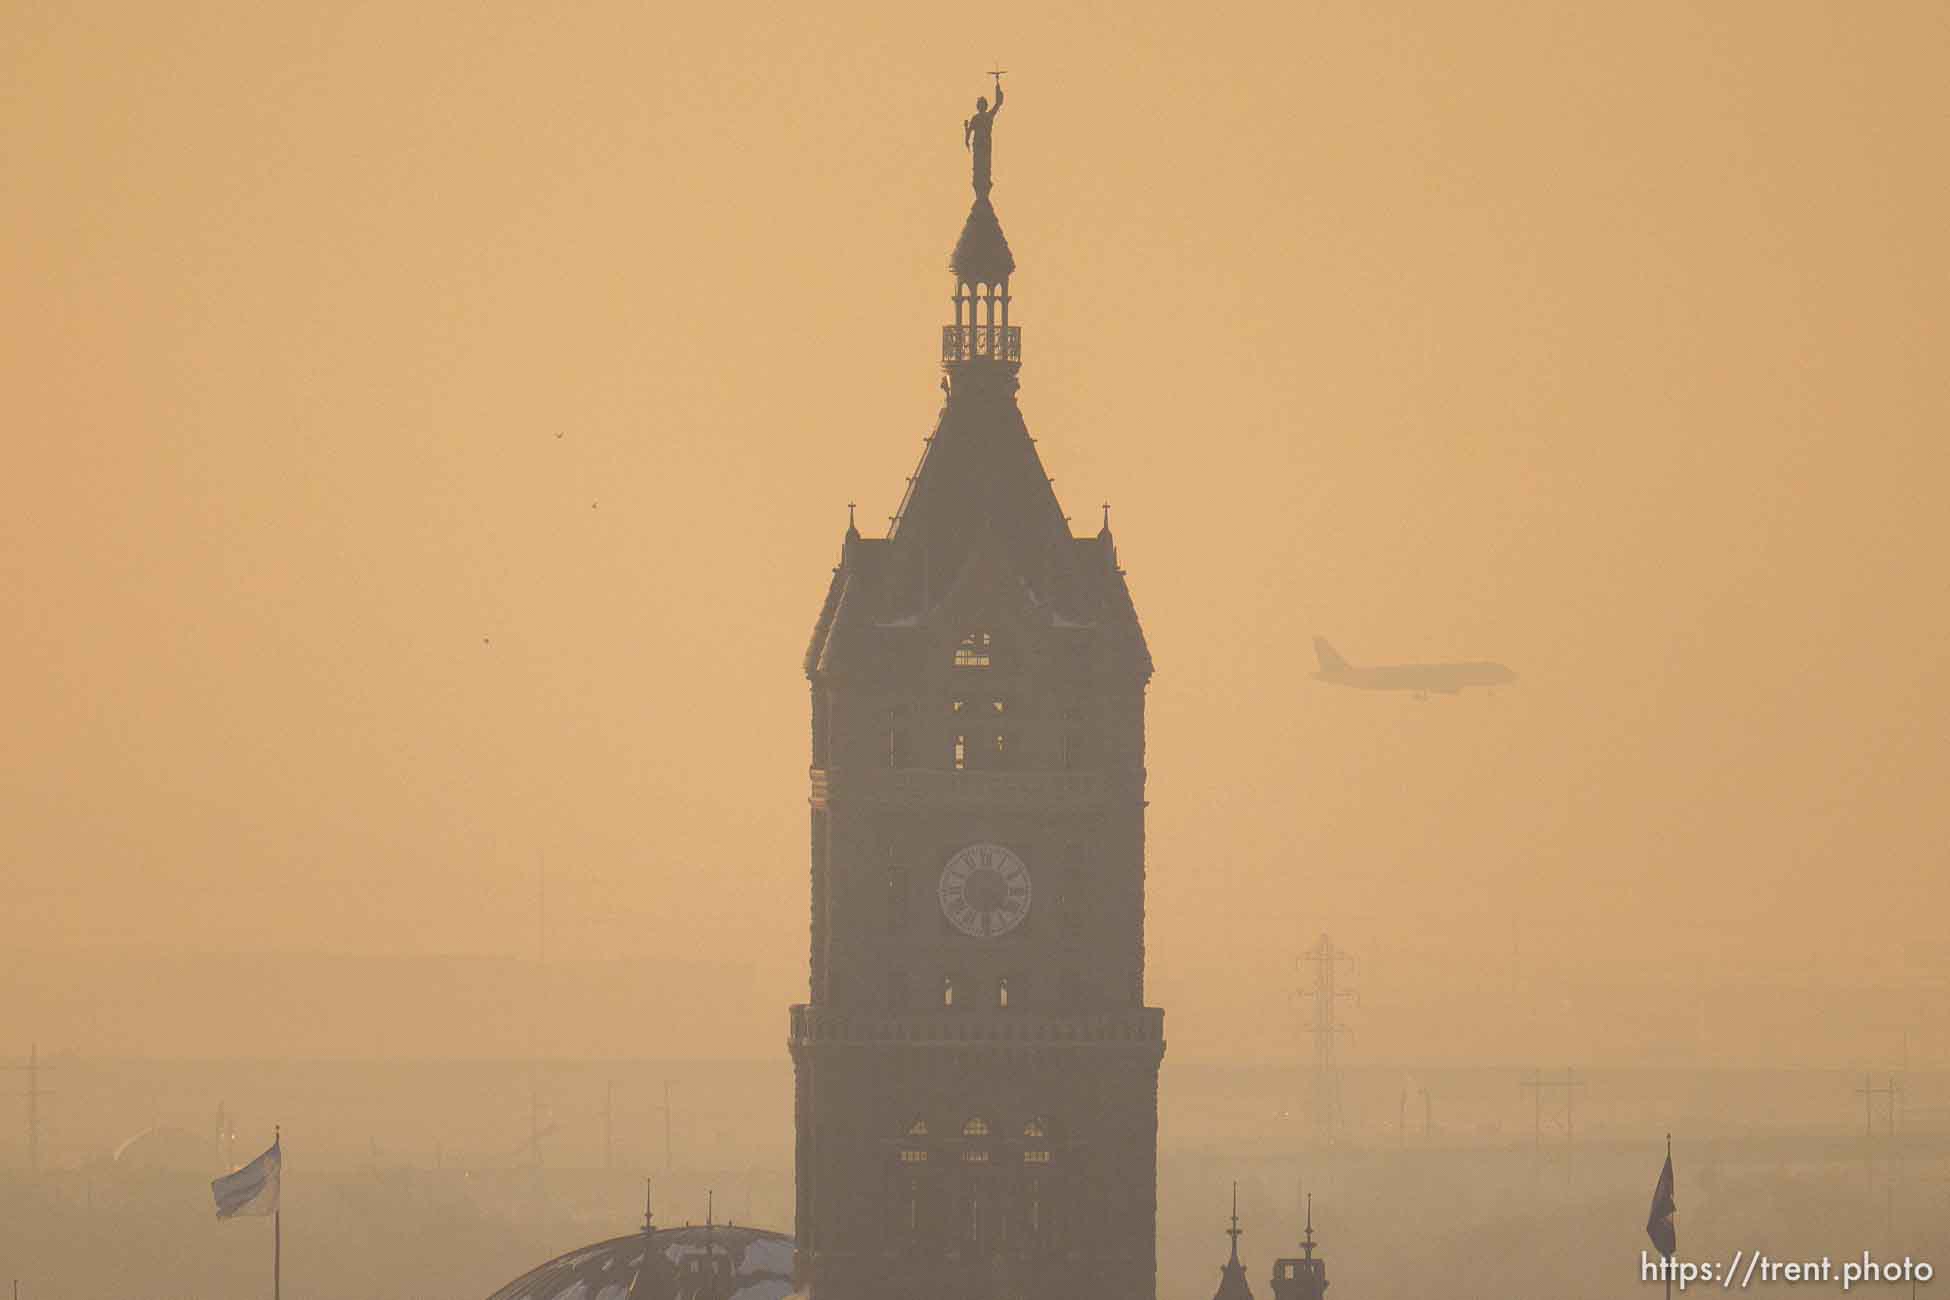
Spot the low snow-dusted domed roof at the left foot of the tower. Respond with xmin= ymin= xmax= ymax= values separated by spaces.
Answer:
xmin=488 ymin=1224 xmax=792 ymax=1300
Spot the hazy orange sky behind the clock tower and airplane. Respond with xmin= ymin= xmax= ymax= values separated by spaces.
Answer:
xmin=0 ymin=0 xmax=1950 ymax=1058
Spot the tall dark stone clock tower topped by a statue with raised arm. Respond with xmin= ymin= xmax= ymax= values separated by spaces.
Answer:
xmin=790 ymin=82 xmax=1164 ymax=1300
